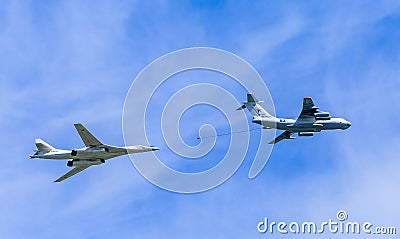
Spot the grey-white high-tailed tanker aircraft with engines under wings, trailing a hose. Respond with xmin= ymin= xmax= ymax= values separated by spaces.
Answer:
xmin=237 ymin=94 xmax=351 ymax=144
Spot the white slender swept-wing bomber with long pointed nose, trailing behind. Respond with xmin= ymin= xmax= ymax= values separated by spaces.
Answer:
xmin=30 ymin=124 xmax=159 ymax=182
